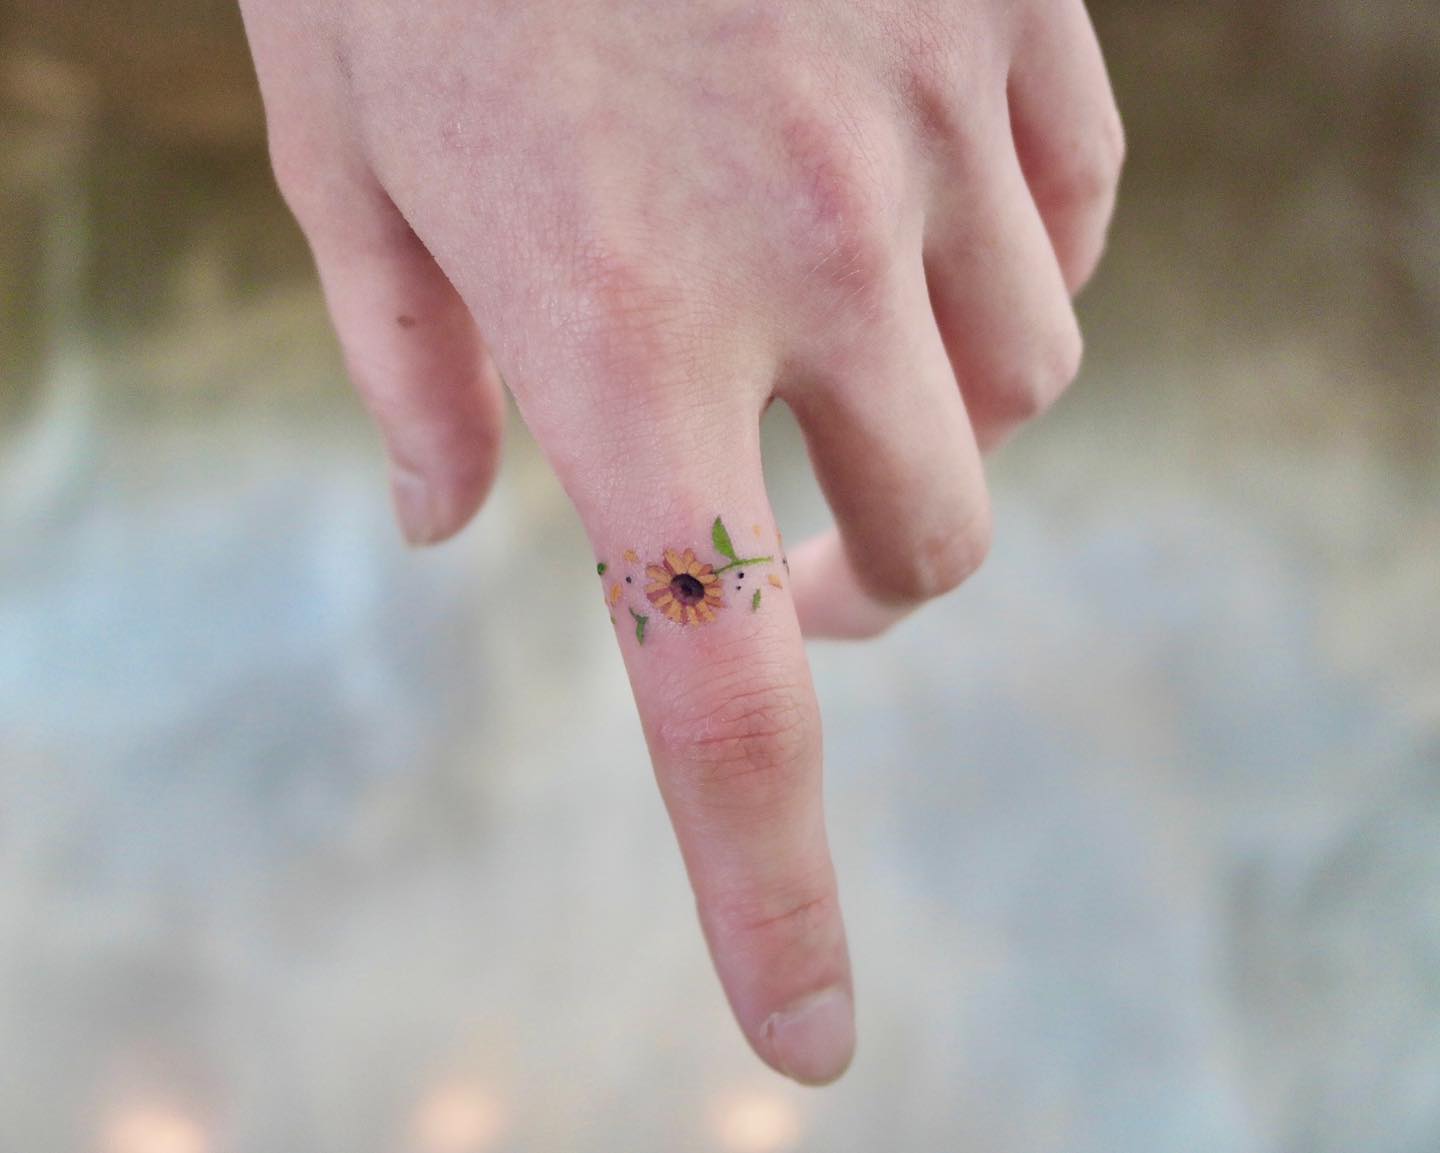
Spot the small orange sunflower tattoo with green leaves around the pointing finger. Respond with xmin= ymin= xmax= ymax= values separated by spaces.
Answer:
xmin=596 ymin=517 xmax=788 ymax=645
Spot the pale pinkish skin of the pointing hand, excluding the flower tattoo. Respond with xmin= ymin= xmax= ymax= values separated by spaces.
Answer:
xmin=242 ymin=0 xmax=1123 ymax=1084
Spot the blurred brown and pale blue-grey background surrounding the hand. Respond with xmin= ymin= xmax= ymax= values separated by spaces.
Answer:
xmin=0 ymin=0 xmax=1440 ymax=1153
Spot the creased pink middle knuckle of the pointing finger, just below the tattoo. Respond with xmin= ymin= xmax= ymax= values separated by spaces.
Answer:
xmin=658 ymin=664 xmax=819 ymax=809
